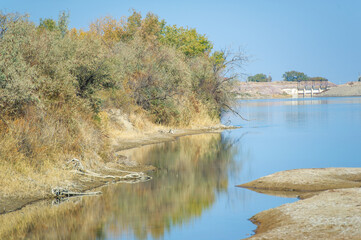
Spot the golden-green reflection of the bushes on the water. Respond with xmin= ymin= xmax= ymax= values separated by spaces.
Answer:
xmin=0 ymin=134 xmax=239 ymax=239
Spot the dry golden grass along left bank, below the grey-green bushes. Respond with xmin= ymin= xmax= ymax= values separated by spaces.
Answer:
xmin=0 ymin=98 xmax=217 ymax=204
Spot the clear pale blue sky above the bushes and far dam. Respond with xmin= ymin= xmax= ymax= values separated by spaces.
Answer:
xmin=0 ymin=0 xmax=361 ymax=84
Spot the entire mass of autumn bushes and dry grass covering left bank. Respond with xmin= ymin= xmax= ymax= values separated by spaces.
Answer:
xmin=0 ymin=11 xmax=246 ymax=206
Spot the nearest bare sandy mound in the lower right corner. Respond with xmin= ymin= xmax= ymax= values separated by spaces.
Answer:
xmin=250 ymin=188 xmax=361 ymax=239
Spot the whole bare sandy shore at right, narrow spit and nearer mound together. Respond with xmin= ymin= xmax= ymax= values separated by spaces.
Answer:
xmin=239 ymin=168 xmax=361 ymax=239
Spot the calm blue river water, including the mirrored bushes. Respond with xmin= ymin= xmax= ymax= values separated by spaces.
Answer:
xmin=19 ymin=98 xmax=361 ymax=240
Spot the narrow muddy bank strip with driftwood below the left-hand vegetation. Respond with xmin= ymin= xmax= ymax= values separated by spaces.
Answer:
xmin=0 ymin=124 xmax=234 ymax=214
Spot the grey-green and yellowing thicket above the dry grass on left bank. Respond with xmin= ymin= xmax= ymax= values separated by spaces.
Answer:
xmin=0 ymin=12 xmax=244 ymax=124
